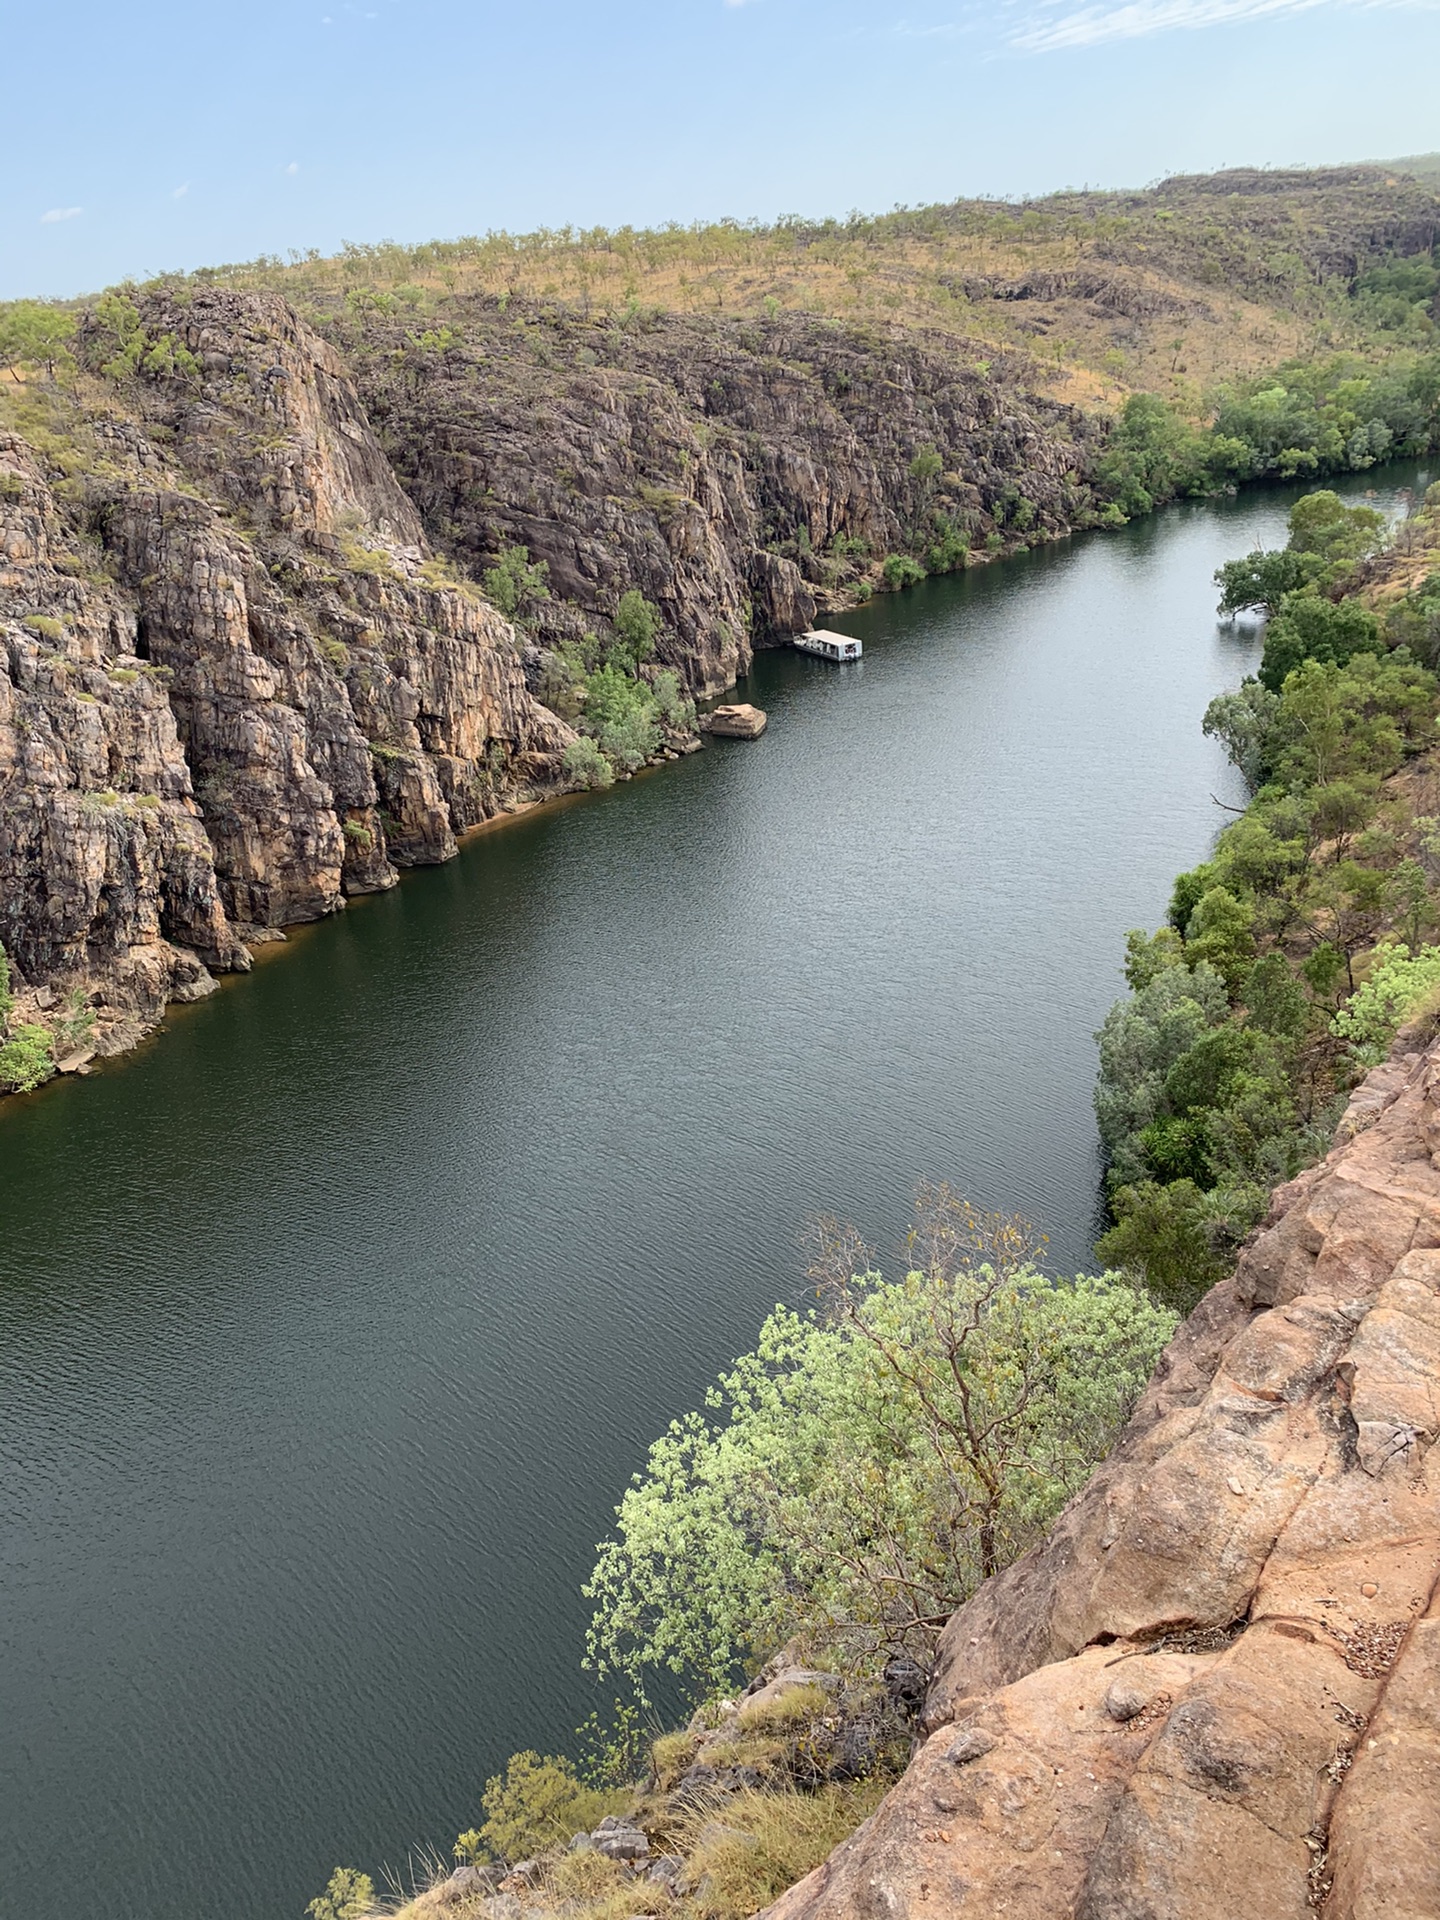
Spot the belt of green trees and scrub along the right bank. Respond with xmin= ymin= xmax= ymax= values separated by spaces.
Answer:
xmin=1096 ymin=488 xmax=1440 ymax=1309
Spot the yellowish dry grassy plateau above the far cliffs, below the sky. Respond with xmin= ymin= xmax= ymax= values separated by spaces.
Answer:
xmin=138 ymin=169 xmax=1430 ymax=411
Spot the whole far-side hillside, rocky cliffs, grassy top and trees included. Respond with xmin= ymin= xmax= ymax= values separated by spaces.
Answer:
xmin=0 ymin=167 xmax=1440 ymax=1085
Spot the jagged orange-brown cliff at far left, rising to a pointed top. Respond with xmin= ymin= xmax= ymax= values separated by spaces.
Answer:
xmin=0 ymin=296 xmax=572 ymax=1050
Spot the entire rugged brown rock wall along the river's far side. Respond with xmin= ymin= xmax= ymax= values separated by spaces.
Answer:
xmin=0 ymin=290 xmax=1098 ymax=1052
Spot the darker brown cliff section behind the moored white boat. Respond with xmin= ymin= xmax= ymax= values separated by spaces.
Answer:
xmin=330 ymin=311 xmax=1098 ymax=693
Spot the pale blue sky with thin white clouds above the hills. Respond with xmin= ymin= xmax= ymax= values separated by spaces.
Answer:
xmin=0 ymin=0 xmax=1440 ymax=298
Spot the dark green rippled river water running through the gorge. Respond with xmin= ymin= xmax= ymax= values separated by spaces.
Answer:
xmin=0 ymin=470 xmax=1407 ymax=1920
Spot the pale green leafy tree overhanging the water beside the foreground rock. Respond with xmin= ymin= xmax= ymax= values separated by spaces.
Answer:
xmin=586 ymin=1187 xmax=1175 ymax=1693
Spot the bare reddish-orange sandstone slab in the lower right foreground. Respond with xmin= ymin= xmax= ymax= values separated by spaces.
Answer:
xmin=770 ymin=1044 xmax=1440 ymax=1920
